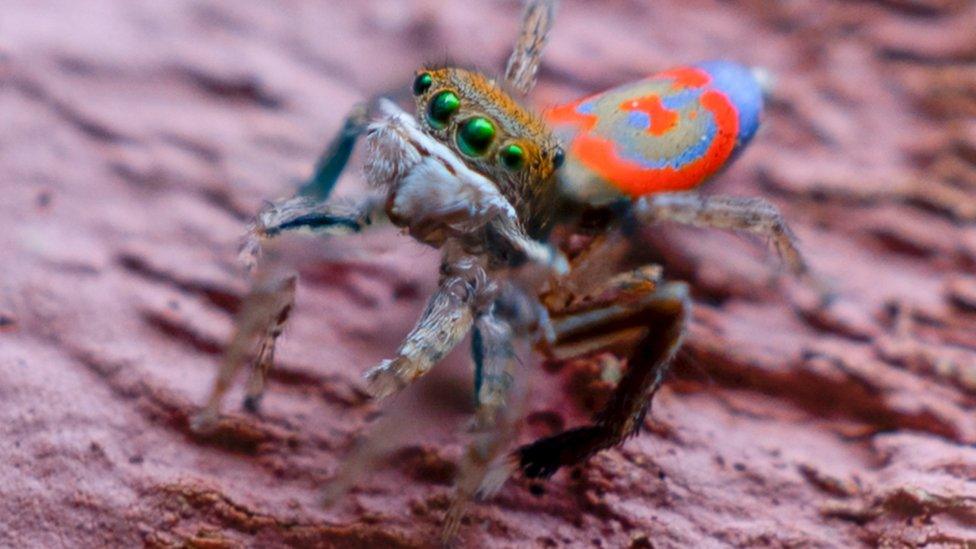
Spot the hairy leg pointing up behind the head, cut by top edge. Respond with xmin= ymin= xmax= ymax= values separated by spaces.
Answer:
xmin=505 ymin=0 xmax=558 ymax=94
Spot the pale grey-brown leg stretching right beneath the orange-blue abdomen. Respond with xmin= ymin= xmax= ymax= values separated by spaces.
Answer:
xmin=633 ymin=193 xmax=810 ymax=276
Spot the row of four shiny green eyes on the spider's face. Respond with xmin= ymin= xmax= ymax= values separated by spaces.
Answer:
xmin=413 ymin=72 xmax=526 ymax=171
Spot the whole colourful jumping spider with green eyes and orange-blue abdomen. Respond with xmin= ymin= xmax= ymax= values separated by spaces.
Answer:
xmin=195 ymin=0 xmax=807 ymax=532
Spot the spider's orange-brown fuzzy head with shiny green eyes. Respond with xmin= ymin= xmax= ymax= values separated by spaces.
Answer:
xmin=413 ymin=68 xmax=563 ymax=216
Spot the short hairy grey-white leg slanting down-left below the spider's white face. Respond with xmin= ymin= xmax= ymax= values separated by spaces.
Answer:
xmin=365 ymin=254 xmax=496 ymax=398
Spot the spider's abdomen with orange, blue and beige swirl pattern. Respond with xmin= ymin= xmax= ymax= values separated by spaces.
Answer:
xmin=545 ymin=61 xmax=763 ymax=203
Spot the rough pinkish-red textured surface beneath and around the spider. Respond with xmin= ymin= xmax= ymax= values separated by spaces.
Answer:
xmin=0 ymin=0 xmax=976 ymax=547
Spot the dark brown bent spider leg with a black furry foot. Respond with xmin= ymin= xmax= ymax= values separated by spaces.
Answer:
xmin=511 ymin=276 xmax=691 ymax=477
